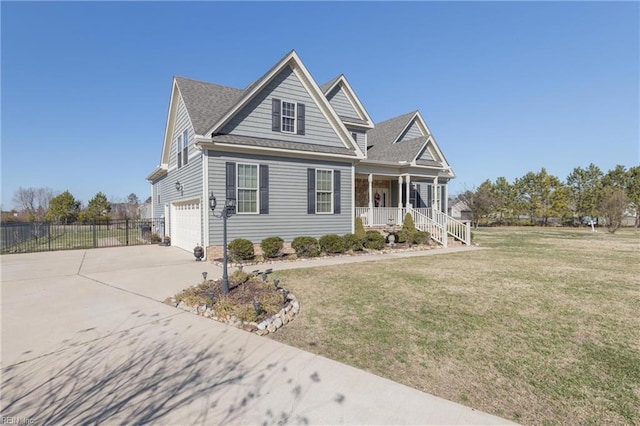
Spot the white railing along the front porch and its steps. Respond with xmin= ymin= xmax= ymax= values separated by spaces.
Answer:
xmin=355 ymin=207 xmax=471 ymax=247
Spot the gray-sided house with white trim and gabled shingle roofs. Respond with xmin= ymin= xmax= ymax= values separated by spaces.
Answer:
xmin=147 ymin=51 xmax=464 ymax=255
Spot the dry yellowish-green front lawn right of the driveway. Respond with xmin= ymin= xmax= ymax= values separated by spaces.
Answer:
xmin=270 ymin=228 xmax=640 ymax=425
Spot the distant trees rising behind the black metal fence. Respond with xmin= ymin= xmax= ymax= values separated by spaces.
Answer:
xmin=3 ymin=187 xmax=151 ymax=224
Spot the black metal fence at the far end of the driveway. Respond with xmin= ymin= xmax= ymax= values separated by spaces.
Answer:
xmin=0 ymin=219 xmax=165 ymax=254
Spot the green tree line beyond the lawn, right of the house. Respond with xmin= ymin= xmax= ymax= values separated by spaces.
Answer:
xmin=458 ymin=163 xmax=640 ymax=232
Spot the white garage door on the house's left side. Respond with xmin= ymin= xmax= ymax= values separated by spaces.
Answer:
xmin=171 ymin=199 xmax=202 ymax=251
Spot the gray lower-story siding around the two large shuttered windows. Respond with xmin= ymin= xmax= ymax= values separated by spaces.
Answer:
xmin=208 ymin=151 xmax=353 ymax=245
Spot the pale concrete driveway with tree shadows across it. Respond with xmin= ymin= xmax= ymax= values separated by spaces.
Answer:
xmin=0 ymin=246 xmax=509 ymax=425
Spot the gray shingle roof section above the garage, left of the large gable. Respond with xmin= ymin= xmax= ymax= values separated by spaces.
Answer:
xmin=175 ymin=77 xmax=244 ymax=135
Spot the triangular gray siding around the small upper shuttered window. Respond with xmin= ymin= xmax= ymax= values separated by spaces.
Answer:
xmin=221 ymin=67 xmax=344 ymax=148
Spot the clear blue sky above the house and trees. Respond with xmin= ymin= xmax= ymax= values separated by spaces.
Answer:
xmin=0 ymin=1 xmax=640 ymax=209
